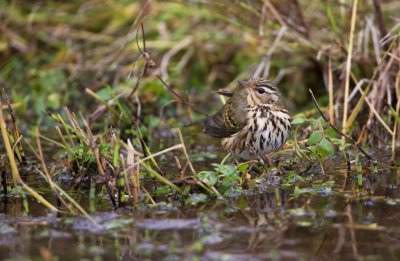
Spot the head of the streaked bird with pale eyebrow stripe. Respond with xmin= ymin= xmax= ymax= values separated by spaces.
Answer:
xmin=239 ymin=79 xmax=281 ymax=105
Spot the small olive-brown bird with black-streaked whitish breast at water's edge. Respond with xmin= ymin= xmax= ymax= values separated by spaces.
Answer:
xmin=203 ymin=78 xmax=291 ymax=162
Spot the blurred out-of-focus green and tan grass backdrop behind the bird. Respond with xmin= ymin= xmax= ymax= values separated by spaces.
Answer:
xmin=0 ymin=0 xmax=400 ymax=142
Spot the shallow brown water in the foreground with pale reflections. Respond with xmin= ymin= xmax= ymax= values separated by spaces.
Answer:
xmin=0 ymin=151 xmax=400 ymax=260
